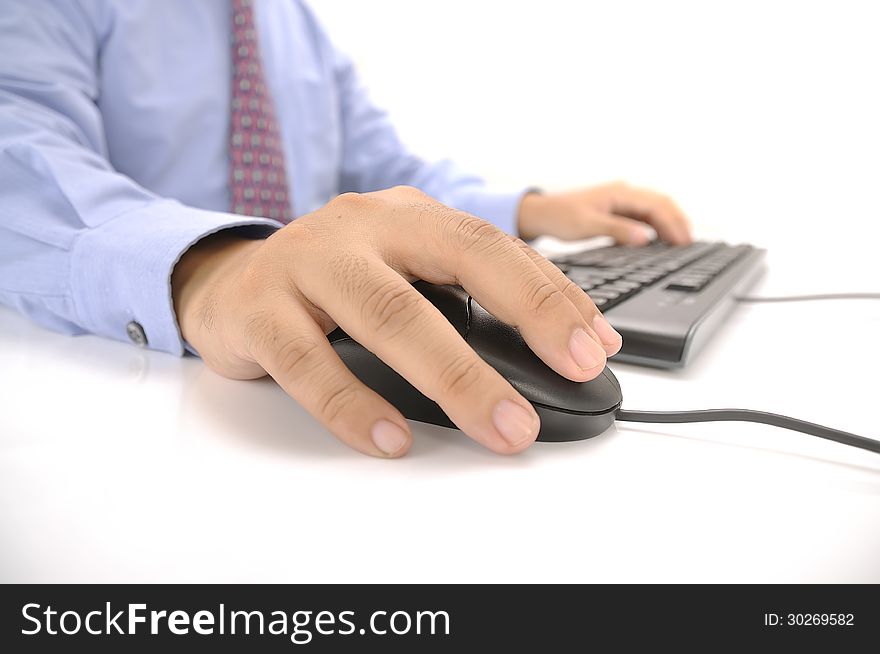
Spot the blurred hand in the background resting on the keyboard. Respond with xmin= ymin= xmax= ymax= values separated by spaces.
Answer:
xmin=518 ymin=182 xmax=691 ymax=245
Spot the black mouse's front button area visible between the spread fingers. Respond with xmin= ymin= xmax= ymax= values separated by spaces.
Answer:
xmin=466 ymin=298 xmax=620 ymax=414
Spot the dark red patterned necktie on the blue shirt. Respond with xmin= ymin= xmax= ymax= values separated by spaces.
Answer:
xmin=229 ymin=0 xmax=291 ymax=223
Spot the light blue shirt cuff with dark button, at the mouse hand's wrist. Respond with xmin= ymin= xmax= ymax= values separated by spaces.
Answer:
xmin=70 ymin=200 xmax=281 ymax=356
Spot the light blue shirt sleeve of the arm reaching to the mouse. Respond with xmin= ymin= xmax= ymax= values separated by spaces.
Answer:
xmin=0 ymin=0 xmax=279 ymax=355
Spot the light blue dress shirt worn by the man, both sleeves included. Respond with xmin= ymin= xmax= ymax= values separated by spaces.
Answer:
xmin=0 ymin=0 xmax=522 ymax=354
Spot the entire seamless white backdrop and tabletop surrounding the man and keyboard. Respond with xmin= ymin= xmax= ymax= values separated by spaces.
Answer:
xmin=0 ymin=0 xmax=880 ymax=584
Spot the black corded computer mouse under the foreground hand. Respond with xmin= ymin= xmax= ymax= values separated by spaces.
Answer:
xmin=328 ymin=282 xmax=622 ymax=441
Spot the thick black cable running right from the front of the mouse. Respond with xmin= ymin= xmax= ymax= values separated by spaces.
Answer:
xmin=617 ymin=409 xmax=880 ymax=454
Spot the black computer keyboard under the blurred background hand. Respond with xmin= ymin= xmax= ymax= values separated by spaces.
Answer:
xmin=554 ymin=242 xmax=765 ymax=368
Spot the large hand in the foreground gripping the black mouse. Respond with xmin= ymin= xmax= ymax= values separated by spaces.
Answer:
xmin=172 ymin=187 xmax=621 ymax=457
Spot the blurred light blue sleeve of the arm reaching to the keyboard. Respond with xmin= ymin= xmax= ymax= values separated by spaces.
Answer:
xmin=302 ymin=5 xmax=535 ymax=234
